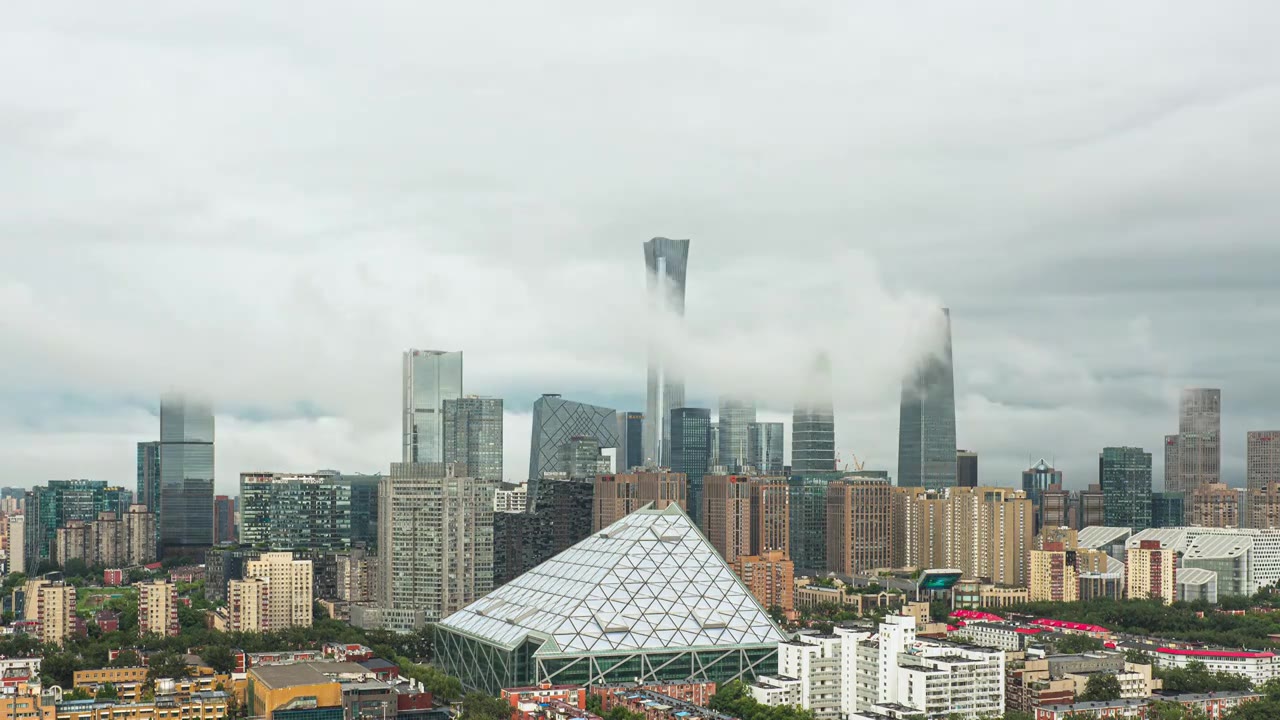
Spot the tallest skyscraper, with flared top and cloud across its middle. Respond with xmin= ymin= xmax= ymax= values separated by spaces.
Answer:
xmin=644 ymin=237 xmax=689 ymax=465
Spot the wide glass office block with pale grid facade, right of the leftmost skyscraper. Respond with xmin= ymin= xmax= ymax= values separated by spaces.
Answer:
xmin=239 ymin=473 xmax=351 ymax=551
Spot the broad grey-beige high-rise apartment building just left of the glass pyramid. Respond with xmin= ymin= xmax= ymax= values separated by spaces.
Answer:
xmin=378 ymin=462 xmax=495 ymax=621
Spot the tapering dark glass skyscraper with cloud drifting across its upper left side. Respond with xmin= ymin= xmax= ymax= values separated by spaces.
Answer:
xmin=897 ymin=307 xmax=956 ymax=488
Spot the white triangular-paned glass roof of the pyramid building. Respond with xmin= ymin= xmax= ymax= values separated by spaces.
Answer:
xmin=440 ymin=505 xmax=783 ymax=655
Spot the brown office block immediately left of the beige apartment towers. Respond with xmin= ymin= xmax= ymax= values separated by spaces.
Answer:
xmin=827 ymin=477 xmax=893 ymax=575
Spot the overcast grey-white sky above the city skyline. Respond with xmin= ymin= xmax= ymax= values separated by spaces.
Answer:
xmin=0 ymin=0 xmax=1280 ymax=492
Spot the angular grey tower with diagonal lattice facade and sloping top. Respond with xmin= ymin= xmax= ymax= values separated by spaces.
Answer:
xmin=529 ymin=393 xmax=618 ymax=496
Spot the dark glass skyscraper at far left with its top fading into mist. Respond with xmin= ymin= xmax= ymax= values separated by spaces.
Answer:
xmin=156 ymin=393 xmax=214 ymax=555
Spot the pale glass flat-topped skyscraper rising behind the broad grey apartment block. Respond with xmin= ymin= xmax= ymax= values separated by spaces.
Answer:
xmin=402 ymin=350 xmax=462 ymax=462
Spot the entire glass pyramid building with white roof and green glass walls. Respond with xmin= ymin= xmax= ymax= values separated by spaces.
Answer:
xmin=435 ymin=505 xmax=783 ymax=694
